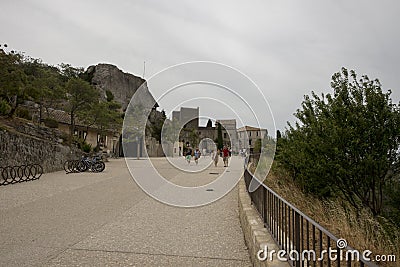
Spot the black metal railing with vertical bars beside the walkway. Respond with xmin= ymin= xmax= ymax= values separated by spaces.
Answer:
xmin=244 ymin=157 xmax=377 ymax=267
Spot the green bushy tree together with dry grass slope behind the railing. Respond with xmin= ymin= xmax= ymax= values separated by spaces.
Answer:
xmin=272 ymin=68 xmax=400 ymax=264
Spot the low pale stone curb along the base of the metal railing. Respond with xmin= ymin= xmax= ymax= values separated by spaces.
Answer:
xmin=238 ymin=177 xmax=290 ymax=267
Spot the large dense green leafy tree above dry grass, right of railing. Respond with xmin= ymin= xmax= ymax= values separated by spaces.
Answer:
xmin=278 ymin=68 xmax=400 ymax=215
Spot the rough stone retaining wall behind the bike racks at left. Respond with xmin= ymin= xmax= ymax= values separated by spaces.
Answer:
xmin=0 ymin=129 xmax=81 ymax=172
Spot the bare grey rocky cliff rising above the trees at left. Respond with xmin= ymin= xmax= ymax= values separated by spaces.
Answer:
xmin=87 ymin=64 xmax=155 ymax=110
